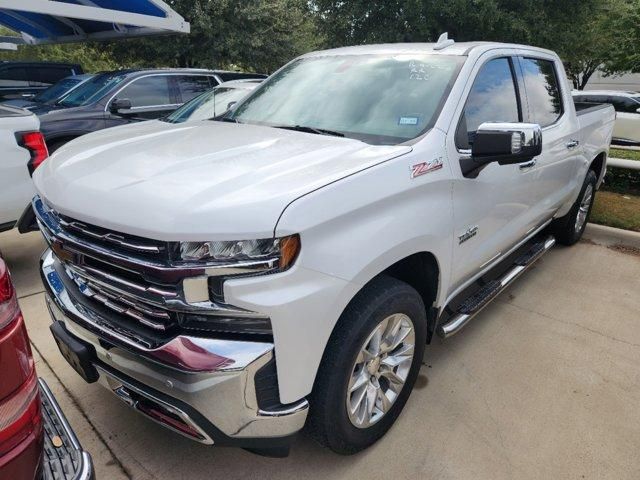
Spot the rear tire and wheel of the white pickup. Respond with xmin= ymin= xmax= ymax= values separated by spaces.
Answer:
xmin=551 ymin=170 xmax=598 ymax=246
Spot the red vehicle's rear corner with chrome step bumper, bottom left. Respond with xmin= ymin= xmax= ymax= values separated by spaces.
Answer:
xmin=0 ymin=255 xmax=93 ymax=480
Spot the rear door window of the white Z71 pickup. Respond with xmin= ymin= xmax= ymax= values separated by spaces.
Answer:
xmin=521 ymin=58 xmax=563 ymax=127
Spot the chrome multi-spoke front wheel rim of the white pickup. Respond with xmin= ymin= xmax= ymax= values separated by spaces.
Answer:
xmin=347 ymin=313 xmax=416 ymax=428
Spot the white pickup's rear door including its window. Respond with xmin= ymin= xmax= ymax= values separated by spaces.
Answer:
xmin=518 ymin=52 xmax=583 ymax=219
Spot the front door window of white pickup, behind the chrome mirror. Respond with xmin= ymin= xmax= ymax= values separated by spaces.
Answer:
xmin=456 ymin=58 xmax=521 ymax=149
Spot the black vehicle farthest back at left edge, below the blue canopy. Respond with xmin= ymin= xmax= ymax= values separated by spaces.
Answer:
xmin=0 ymin=62 xmax=84 ymax=102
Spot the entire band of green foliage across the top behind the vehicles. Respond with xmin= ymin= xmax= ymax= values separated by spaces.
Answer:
xmin=0 ymin=0 xmax=640 ymax=84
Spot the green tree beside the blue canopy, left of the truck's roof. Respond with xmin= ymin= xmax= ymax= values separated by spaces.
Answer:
xmin=107 ymin=0 xmax=321 ymax=72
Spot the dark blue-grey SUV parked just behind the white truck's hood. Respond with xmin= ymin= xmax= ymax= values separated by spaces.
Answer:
xmin=34 ymin=69 xmax=268 ymax=152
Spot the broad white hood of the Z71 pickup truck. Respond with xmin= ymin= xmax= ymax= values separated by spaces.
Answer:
xmin=34 ymin=121 xmax=411 ymax=241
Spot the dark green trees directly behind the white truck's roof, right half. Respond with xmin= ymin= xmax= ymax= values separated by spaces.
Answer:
xmin=313 ymin=0 xmax=640 ymax=89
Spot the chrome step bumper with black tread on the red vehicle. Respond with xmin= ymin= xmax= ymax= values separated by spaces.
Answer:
xmin=38 ymin=379 xmax=94 ymax=480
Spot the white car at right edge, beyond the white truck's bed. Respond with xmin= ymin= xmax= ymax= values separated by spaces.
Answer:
xmin=573 ymin=90 xmax=640 ymax=144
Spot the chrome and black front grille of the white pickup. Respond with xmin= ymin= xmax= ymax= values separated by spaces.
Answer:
xmin=33 ymin=197 xmax=271 ymax=348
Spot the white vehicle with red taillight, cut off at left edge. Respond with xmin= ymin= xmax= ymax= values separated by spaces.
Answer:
xmin=0 ymin=105 xmax=49 ymax=232
